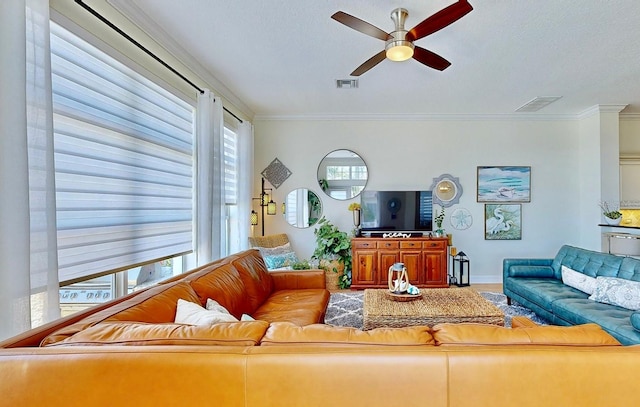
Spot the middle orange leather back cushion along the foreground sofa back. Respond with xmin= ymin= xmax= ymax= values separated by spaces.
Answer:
xmin=260 ymin=322 xmax=435 ymax=346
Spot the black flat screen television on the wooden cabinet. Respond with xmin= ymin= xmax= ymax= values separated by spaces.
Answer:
xmin=360 ymin=190 xmax=433 ymax=233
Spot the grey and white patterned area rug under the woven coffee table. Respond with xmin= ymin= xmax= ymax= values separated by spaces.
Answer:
xmin=324 ymin=291 xmax=549 ymax=329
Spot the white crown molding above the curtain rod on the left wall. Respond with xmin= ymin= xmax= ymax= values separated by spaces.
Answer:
xmin=106 ymin=0 xmax=255 ymax=120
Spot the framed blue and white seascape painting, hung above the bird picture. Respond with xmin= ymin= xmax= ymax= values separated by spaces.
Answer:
xmin=477 ymin=166 xmax=531 ymax=202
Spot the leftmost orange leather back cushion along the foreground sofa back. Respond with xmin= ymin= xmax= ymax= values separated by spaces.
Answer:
xmin=49 ymin=321 xmax=269 ymax=346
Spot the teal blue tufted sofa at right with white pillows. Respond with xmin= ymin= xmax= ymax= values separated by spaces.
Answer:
xmin=502 ymin=245 xmax=640 ymax=345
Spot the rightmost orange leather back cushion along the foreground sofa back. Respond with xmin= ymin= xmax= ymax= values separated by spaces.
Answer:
xmin=432 ymin=323 xmax=620 ymax=346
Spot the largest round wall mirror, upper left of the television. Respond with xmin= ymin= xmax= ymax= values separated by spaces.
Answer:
xmin=318 ymin=150 xmax=369 ymax=201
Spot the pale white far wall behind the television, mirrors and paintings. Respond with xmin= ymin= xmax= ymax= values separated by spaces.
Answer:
xmin=254 ymin=120 xmax=584 ymax=283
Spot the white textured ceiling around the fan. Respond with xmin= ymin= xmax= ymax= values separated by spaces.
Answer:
xmin=110 ymin=0 xmax=640 ymax=117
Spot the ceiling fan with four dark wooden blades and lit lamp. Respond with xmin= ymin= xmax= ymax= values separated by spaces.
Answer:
xmin=331 ymin=0 xmax=473 ymax=76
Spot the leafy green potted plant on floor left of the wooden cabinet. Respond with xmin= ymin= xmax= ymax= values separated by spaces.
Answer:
xmin=311 ymin=217 xmax=351 ymax=289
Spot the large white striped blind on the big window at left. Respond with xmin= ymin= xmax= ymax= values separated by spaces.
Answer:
xmin=51 ymin=23 xmax=194 ymax=283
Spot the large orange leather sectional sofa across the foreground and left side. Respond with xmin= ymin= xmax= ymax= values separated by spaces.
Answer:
xmin=0 ymin=250 xmax=640 ymax=407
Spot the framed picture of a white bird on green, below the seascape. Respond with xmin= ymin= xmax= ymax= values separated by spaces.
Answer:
xmin=484 ymin=204 xmax=522 ymax=240
